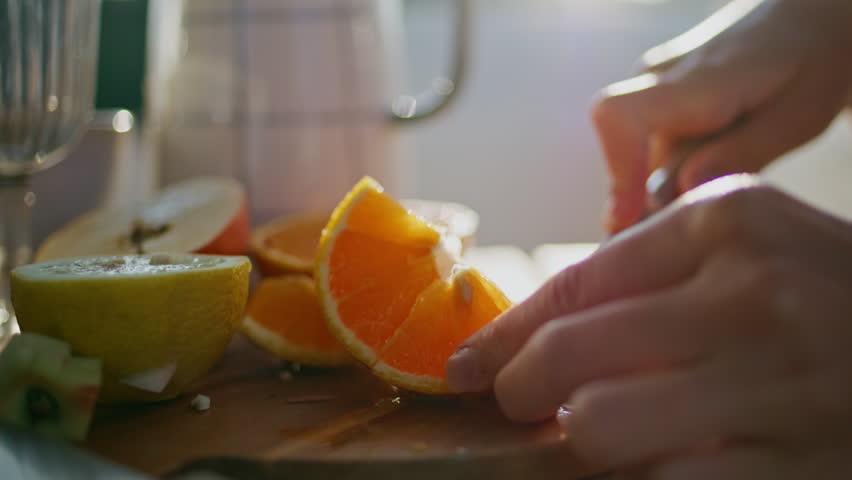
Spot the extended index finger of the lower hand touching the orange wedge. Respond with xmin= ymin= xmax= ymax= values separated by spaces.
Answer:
xmin=446 ymin=206 xmax=706 ymax=392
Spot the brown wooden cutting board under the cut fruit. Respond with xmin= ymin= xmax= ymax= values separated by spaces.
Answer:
xmin=85 ymin=336 xmax=594 ymax=480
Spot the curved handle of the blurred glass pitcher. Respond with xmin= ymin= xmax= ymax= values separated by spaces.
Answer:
xmin=388 ymin=0 xmax=472 ymax=124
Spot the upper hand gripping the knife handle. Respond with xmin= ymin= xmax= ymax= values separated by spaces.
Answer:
xmin=592 ymin=0 xmax=852 ymax=233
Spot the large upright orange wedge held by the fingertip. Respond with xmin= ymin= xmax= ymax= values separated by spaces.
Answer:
xmin=314 ymin=177 xmax=510 ymax=394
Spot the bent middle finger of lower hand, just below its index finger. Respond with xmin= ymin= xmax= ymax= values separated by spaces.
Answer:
xmin=494 ymin=289 xmax=719 ymax=421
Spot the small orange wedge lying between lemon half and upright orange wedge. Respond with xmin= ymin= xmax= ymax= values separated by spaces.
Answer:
xmin=241 ymin=274 xmax=352 ymax=367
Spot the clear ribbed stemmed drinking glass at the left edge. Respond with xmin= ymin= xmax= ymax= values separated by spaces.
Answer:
xmin=0 ymin=0 xmax=100 ymax=348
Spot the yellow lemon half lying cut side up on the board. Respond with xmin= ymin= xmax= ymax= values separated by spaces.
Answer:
xmin=11 ymin=254 xmax=251 ymax=403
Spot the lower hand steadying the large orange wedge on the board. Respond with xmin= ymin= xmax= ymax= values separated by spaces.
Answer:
xmin=447 ymin=175 xmax=852 ymax=480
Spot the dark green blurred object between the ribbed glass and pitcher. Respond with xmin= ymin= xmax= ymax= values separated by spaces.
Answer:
xmin=95 ymin=0 xmax=148 ymax=115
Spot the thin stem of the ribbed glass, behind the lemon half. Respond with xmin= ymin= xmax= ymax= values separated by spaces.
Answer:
xmin=0 ymin=175 xmax=35 ymax=349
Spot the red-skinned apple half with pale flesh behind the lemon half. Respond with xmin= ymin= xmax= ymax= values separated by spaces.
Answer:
xmin=34 ymin=177 xmax=251 ymax=262
